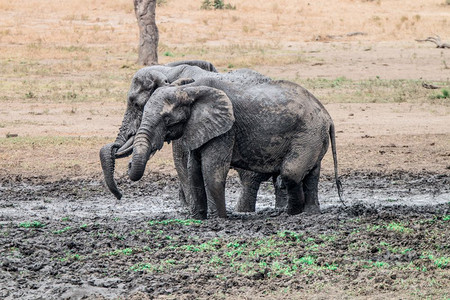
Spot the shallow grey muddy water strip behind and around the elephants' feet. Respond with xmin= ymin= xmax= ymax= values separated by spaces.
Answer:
xmin=0 ymin=173 xmax=450 ymax=219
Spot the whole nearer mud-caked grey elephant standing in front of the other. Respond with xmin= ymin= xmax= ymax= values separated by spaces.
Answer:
xmin=129 ymin=70 xmax=341 ymax=219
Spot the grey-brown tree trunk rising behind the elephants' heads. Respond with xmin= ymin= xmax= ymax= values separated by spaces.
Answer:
xmin=134 ymin=0 xmax=159 ymax=66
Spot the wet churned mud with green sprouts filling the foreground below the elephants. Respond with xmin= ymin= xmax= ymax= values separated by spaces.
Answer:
xmin=0 ymin=172 xmax=450 ymax=299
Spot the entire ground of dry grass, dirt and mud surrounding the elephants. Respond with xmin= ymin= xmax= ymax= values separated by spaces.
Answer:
xmin=0 ymin=0 xmax=450 ymax=299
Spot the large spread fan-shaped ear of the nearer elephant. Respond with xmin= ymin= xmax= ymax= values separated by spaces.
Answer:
xmin=180 ymin=86 xmax=234 ymax=150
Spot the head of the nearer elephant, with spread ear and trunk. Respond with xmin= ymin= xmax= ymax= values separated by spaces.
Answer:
xmin=128 ymin=85 xmax=234 ymax=181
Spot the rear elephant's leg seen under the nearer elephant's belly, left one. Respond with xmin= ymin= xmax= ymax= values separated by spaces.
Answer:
xmin=236 ymin=169 xmax=270 ymax=212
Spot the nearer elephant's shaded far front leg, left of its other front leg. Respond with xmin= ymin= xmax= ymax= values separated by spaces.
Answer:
xmin=187 ymin=151 xmax=208 ymax=220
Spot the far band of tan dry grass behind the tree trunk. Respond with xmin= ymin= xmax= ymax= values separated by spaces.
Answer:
xmin=0 ymin=0 xmax=450 ymax=70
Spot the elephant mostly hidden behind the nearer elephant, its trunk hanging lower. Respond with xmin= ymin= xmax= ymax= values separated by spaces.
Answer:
xmin=100 ymin=60 xmax=285 ymax=211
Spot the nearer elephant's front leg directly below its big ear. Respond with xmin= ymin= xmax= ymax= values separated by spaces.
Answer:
xmin=201 ymin=135 xmax=234 ymax=218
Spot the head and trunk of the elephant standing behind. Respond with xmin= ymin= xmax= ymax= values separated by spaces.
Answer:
xmin=100 ymin=67 xmax=169 ymax=199
